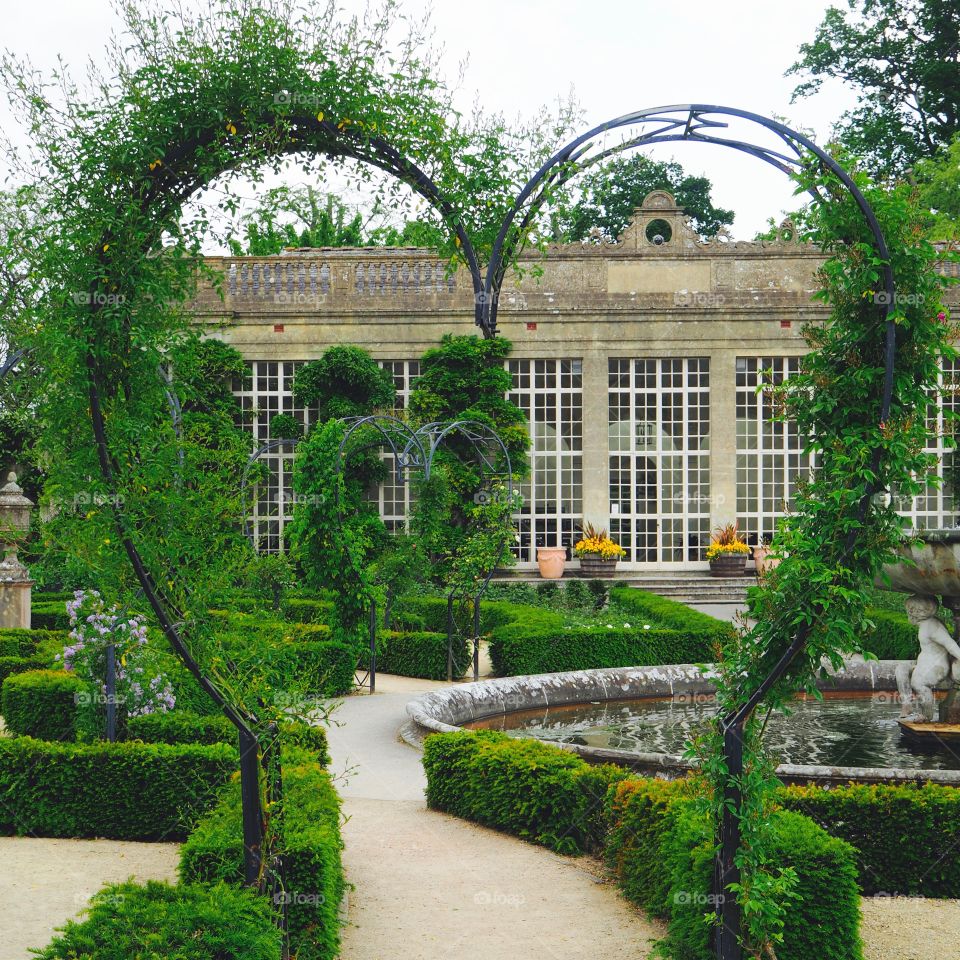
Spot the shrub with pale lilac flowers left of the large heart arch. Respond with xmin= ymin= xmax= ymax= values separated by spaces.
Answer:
xmin=56 ymin=590 xmax=176 ymax=717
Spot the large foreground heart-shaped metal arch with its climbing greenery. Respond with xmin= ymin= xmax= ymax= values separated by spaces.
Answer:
xmin=5 ymin=0 xmax=955 ymax=960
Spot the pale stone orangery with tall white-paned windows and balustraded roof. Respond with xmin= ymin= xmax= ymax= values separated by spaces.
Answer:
xmin=189 ymin=191 xmax=960 ymax=571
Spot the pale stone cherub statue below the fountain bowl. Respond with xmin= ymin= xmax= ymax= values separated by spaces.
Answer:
xmin=897 ymin=595 xmax=960 ymax=723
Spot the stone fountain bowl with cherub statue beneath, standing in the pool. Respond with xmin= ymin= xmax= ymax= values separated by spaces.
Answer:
xmin=877 ymin=529 xmax=960 ymax=740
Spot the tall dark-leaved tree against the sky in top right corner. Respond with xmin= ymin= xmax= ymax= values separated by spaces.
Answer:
xmin=787 ymin=0 xmax=960 ymax=177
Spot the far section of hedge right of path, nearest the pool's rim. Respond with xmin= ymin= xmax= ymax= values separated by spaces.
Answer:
xmin=423 ymin=730 xmax=627 ymax=853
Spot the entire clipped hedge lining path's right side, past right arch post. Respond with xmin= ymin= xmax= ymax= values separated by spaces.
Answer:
xmin=423 ymin=731 xmax=862 ymax=960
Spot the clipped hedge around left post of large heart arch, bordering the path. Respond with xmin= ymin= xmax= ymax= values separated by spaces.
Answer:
xmin=180 ymin=749 xmax=345 ymax=960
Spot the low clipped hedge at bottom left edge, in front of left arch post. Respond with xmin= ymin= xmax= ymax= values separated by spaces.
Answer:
xmin=36 ymin=880 xmax=281 ymax=960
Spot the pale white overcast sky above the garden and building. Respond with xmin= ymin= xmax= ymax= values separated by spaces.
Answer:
xmin=0 ymin=0 xmax=853 ymax=238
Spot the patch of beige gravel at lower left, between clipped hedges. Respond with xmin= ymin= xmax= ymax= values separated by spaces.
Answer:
xmin=0 ymin=837 xmax=179 ymax=960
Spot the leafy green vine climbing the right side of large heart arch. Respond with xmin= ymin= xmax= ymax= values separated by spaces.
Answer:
xmin=693 ymin=168 xmax=958 ymax=957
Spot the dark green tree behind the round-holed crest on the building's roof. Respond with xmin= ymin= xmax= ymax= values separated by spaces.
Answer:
xmin=551 ymin=154 xmax=733 ymax=243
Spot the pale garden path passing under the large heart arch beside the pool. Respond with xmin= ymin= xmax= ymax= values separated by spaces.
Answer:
xmin=328 ymin=675 xmax=663 ymax=960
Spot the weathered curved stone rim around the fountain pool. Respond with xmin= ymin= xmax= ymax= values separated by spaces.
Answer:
xmin=400 ymin=660 xmax=960 ymax=787
